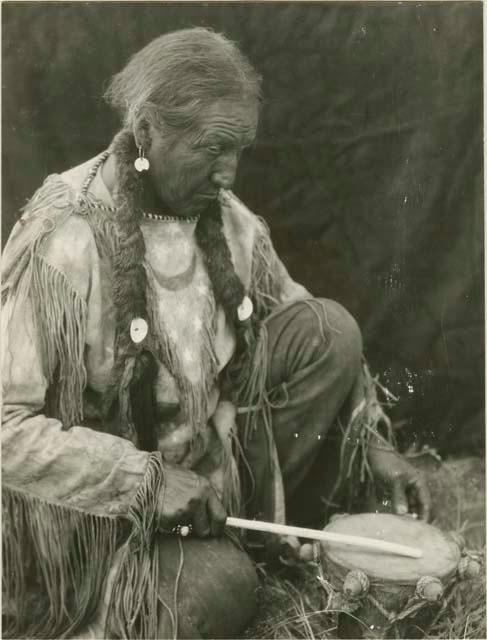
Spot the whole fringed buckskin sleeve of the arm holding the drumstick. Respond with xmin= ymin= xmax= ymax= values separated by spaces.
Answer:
xmin=2 ymin=182 xmax=164 ymax=638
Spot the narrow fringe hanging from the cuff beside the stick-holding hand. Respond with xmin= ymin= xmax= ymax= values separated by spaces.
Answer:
xmin=105 ymin=453 xmax=164 ymax=640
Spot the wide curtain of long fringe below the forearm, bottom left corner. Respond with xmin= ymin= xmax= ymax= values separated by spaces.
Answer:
xmin=2 ymin=484 xmax=117 ymax=638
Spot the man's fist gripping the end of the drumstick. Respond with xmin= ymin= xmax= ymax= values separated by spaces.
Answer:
xmin=159 ymin=465 xmax=227 ymax=537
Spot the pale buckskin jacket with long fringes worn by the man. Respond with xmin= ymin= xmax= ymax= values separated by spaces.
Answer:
xmin=2 ymin=156 xmax=310 ymax=637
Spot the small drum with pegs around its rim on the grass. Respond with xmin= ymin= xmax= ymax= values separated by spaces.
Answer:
xmin=320 ymin=513 xmax=479 ymax=638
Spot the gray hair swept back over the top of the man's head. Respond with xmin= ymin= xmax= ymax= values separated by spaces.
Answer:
xmin=104 ymin=27 xmax=261 ymax=131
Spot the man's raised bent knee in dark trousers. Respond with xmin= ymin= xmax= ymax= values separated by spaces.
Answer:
xmin=267 ymin=300 xmax=362 ymax=499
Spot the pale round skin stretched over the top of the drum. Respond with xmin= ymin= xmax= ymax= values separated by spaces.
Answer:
xmin=321 ymin=513 xmax=460 ymax=584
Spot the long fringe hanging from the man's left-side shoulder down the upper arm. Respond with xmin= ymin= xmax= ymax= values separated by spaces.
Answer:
xmin=2 ymin=174 xmax=111 ymax=429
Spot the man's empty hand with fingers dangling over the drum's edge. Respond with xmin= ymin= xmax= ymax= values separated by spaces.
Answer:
xmin=368 ymin=443 xmax=431 ymax=522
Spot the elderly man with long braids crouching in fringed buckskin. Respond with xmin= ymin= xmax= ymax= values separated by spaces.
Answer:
xmin=2 ymin=29 xmax=428 ymax=638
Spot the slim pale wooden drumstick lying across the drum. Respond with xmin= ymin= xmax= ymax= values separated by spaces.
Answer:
xmin=225 ymin=516 xmax=423 ymax=558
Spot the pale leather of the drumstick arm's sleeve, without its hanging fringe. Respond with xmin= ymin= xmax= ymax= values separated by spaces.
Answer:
xmin=2 ymin=212 xmax=155 ymax=515
